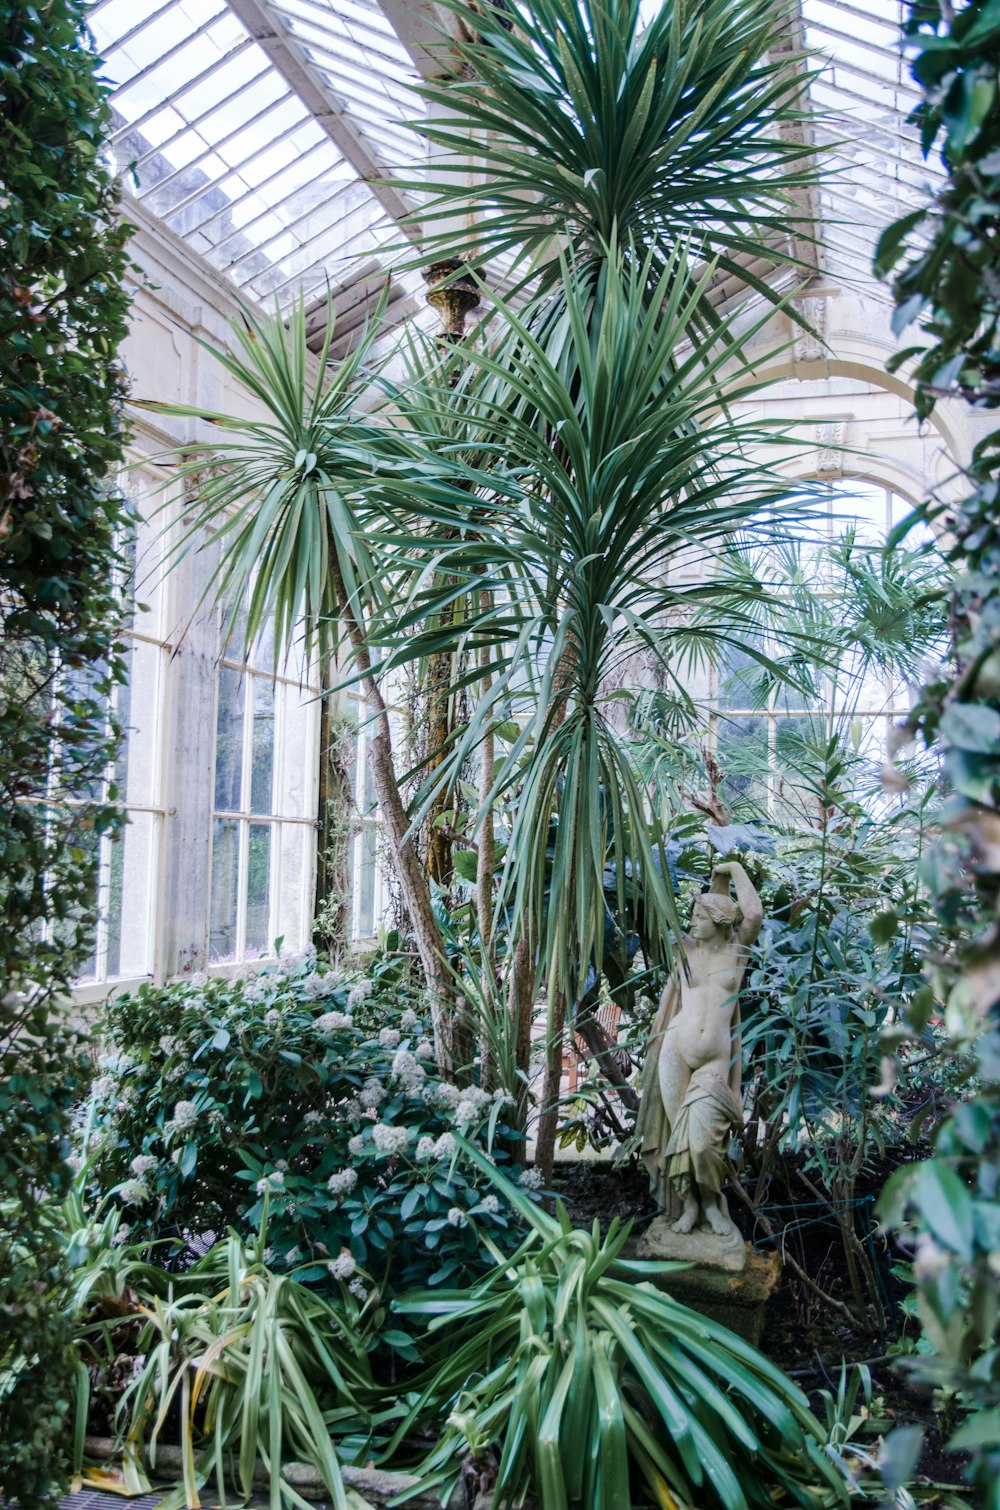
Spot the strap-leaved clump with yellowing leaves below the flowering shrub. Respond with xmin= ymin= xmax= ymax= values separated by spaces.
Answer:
xmin=77 ymin=1234 xmax=372 ymax=1510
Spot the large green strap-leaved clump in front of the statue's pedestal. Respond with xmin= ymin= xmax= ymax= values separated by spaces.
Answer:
xmin=386 ymin=1141 xmax=846 ymax=1510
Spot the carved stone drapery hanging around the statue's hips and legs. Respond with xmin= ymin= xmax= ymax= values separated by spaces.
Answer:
xmin=636 ymin=977 xmax=743 ymax=1222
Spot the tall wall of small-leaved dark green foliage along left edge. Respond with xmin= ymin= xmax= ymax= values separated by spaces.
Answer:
xmin=0 ymin=0 xmax=128 ymax=1510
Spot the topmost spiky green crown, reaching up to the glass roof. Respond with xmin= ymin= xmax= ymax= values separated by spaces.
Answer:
xmin=398 ymin=0 xmax=816 ymax=326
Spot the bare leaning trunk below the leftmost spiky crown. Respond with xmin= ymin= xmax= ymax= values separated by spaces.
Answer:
xmin=329 ymin=542 xmax=459 ymax=1078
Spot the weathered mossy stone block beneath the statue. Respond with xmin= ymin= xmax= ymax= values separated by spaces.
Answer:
xmin=634 ymin=1219 xmax=781 ymax=1347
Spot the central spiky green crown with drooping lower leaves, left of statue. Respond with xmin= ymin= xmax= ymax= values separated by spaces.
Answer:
xmin=369 ymin=235 xmax=821 ymax=1163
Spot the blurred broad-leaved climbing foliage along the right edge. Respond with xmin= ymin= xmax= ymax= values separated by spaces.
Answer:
xmin=876 ymin=0 xmax=1000 ymax=1510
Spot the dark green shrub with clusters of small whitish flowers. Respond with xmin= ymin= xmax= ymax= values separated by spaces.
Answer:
xmin=82 ymin=959 xmax=520 ymax=1299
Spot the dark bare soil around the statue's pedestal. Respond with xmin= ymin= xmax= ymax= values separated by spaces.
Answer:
xmin=554 ymin=1163 xmax=964 ymax=1487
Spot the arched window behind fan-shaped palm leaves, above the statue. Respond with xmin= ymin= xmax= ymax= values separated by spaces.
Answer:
xmin=710 ymin=479 xmax=944 ymax=812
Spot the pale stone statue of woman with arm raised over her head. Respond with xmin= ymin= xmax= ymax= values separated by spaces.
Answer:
xmin=637 ymin=861 xmax=764 ymax=1250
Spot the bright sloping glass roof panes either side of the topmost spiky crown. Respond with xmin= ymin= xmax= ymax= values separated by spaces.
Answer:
xmin=91 ymin=0 xmax=935 ymax=325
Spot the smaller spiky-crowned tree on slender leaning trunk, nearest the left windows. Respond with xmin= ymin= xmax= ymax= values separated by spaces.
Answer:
xmin=144 ymin=302 xmax=516 ymax=1072
